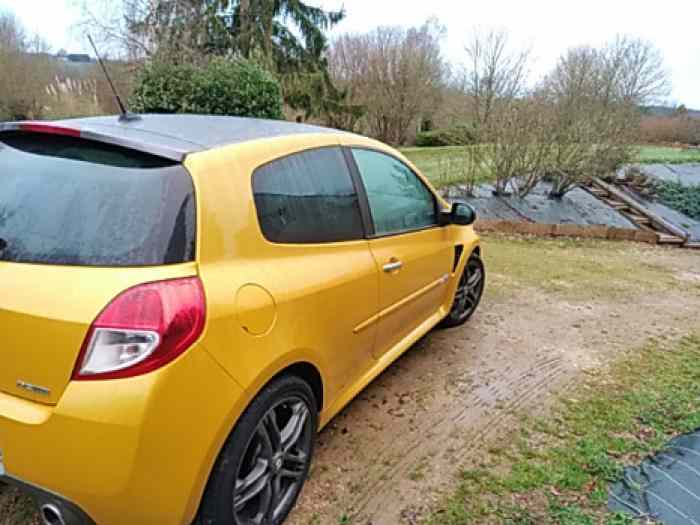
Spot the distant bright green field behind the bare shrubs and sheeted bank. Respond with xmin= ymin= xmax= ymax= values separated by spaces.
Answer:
xmin=401 ymin=146 xmax=700 ymax=188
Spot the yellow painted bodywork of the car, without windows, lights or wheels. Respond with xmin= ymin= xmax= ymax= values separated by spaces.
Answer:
xmin=0 ymin=129 xmax=478 ymax=525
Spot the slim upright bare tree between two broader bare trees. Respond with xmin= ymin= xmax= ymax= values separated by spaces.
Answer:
xmin=463 ymin=30 xmax=529 ymax=129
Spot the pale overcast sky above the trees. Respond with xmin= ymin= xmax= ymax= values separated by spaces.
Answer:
xmin=0 ymin=0 xmax=700 ymax=109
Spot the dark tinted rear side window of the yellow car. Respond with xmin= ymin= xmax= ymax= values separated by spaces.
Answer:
xmin=253 ymin=148 xmax=364 ymax=243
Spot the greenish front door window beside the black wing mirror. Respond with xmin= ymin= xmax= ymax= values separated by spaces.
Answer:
xmin=352 ymin=149 xmax=438 ymax=235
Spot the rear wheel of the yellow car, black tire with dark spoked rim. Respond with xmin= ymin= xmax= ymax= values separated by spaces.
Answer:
xmin=194 ymin=376 xmax=318 ymax=525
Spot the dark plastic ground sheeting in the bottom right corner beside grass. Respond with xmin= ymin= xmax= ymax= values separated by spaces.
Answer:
xmin=608 ymin=430 xmax=700 ymax=525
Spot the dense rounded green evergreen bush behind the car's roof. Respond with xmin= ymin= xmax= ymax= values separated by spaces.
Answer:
xmin=131 ymin=58 xmax=282 ymax=119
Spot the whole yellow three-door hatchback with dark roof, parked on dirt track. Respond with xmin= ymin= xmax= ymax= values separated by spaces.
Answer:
xmin=0 ymin=115 xmax=484 ymax=525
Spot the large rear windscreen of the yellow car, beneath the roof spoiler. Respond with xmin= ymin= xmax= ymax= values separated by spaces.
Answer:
xmin=0 ymin=132 xmax=195 ymax=266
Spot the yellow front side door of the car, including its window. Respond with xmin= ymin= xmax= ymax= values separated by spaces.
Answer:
xmin=350 ymin=148 xmax=454 ymax=358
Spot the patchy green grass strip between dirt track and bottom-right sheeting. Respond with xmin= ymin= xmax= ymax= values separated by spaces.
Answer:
xmin=426 ymin=335 xmax=700 ymax=525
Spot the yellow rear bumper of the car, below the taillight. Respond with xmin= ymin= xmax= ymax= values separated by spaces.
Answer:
xmin=0 ymin=347 xmax=245 ymax=525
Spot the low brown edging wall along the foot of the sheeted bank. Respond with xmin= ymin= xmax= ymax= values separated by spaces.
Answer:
xmin=474 ymin=219 xmax=659 ymax=244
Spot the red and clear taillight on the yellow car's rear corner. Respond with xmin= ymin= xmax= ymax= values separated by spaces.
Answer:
xmin=73 ymin=277 xmax=205 ymax=380
